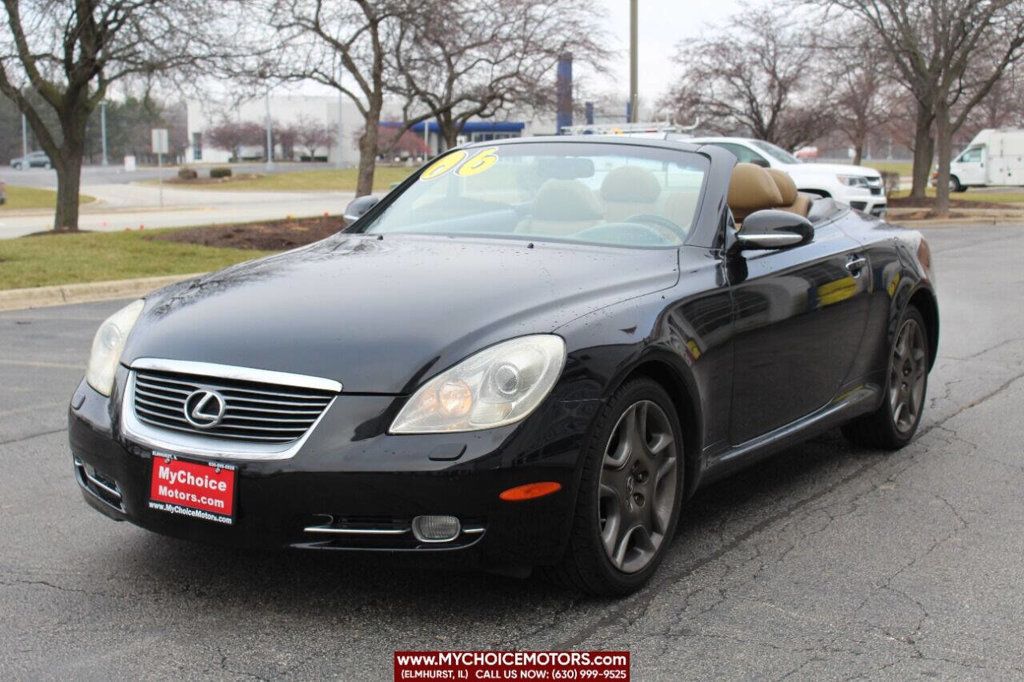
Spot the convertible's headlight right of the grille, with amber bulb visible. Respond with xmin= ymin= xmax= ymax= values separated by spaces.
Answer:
xmin=391 ymin=334 xmax=565 ymax=433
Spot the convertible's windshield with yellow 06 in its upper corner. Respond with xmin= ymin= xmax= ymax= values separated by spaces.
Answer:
xmin=360 ymin=142 xmax=708 ymax=247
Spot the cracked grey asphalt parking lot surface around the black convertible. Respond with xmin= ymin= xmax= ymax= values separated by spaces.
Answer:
xmin=0 ymin=226 xmax=1024 ymax=680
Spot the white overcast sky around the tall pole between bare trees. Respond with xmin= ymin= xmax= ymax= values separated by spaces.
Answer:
xmin=588 ymin=0 xmax=755 ymax=103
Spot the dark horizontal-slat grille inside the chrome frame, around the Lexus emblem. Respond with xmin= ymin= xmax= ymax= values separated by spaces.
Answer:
xmin=132 ymin=370 xmax=335 ymax=443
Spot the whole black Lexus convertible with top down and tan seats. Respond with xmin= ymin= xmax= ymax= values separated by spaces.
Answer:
xmin=70 ymin=136 xmax=938 ymax=594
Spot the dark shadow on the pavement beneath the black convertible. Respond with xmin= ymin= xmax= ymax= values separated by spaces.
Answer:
xmin=108 ymin=425 xmax=886 ymax=621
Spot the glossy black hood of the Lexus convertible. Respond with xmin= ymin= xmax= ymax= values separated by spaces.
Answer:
xmin=122 ymin=235 xmax=679 ymax=394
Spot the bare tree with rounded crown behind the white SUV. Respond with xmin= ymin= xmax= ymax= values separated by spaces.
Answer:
xmin=663 ymin=9 xmax=831 ymax=148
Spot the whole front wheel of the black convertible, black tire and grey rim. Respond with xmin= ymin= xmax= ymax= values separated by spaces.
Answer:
xmin=545 ymin=379 xmax=685 ymax=596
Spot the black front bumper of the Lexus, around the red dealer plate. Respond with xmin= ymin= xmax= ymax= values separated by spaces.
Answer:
xmin=69 ymin=371 xmax=599 ymax=565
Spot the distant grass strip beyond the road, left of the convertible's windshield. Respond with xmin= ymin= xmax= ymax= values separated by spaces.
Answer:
xmin=159 ymin=166 xmax=417 ymax=191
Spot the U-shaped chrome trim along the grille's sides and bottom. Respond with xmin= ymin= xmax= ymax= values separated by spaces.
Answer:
xmin=121 ymin=372 xmax=341 ymax=462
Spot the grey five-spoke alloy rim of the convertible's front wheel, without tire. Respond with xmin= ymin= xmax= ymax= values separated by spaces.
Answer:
xmin=598 ymin=400 xmax=680 ymax=573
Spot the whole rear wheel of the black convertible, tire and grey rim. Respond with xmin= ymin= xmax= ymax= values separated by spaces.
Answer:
xmin=843 ymin=305 xmax=931 ymax=450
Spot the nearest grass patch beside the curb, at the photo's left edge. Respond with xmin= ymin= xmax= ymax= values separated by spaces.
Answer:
xmin=0 ymin=230 xmax=269 ymax=289
